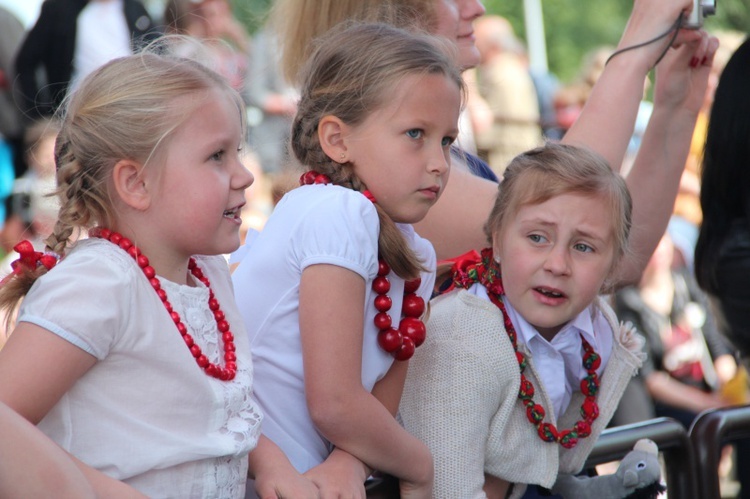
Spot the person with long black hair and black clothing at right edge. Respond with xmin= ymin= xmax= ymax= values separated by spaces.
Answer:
xmin=695 ymin=40 xmax=750 ymax=357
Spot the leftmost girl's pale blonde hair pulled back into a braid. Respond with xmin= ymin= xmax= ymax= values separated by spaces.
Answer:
xmin=0 ymin=53 xmax=245 ymax=316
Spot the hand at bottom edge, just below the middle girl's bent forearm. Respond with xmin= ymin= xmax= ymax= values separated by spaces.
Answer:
xmin=304 ymin=449 xmax=370 ymax=499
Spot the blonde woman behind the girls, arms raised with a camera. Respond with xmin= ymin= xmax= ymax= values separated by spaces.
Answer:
xmin=274 ymin=0 xmax=718 ymax=282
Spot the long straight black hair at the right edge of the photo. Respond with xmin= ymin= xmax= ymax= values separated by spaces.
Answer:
xmin=695 ymin=39 xmax=750 ymax=294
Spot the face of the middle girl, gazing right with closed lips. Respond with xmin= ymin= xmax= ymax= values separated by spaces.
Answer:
xmin=346 ymin=75 xmax=461 ymax=223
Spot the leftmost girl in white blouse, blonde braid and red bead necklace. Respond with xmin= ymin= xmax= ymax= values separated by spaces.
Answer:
xmin=0 ymin=54 xmax=312 ymax=498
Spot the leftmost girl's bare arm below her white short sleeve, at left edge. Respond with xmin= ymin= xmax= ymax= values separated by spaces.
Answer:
xmin=0 ymin=322 xmax=144 ymax=498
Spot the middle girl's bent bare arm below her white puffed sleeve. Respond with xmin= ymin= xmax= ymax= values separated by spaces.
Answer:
xmin=300 ymin=265 xmax=433 ymax=498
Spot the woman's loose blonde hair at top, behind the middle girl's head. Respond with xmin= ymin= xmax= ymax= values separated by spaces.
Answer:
xmin=271 ymin=0 xmax=443 ymax=83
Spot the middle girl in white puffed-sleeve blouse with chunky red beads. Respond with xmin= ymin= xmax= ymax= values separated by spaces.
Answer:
xmin=233 ymin=24 xmax=463 ymax=497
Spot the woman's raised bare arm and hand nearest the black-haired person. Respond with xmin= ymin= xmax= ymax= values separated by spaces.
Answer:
xmin=619 ymin=32 xmax=718 ymax=283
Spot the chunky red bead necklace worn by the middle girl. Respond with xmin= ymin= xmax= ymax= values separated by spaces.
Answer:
xmin=299 ymin=170 xmax=427 ymax=360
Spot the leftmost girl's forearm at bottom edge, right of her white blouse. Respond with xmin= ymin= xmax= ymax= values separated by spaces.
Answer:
xmin=248 ymin=435 xmax=318 ymax=499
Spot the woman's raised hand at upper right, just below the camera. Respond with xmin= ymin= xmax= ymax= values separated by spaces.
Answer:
xmin=654 ymin=30 xmax=719 ymax=114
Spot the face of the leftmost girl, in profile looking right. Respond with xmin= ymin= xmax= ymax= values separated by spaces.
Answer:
xmin=145 ymin=90 xmax=253 ymax=257
